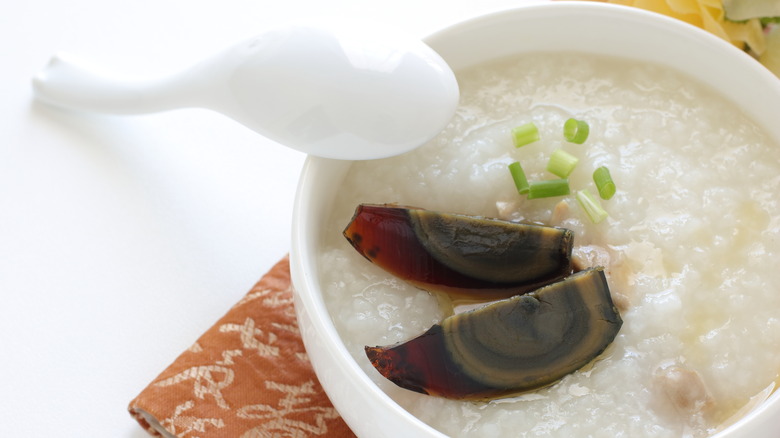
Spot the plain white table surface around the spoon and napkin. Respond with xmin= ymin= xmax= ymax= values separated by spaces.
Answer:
xmin=0 ymin=0 xmax=544 ymax=438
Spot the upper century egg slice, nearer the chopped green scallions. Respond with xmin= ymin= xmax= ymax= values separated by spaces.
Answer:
xmin=344 ymin=204 xmax=573 ymax=299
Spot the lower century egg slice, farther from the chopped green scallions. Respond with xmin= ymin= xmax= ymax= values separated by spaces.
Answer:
xmin=365 ymin=268 xmax=623 ymax=400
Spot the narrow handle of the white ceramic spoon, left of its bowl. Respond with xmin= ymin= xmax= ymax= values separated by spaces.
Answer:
xmin=33 ymin=53 xmax=200 ymax=114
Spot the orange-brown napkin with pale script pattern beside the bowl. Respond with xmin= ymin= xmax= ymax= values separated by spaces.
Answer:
xmin=128 ymin=257 xmax=355 ymax=438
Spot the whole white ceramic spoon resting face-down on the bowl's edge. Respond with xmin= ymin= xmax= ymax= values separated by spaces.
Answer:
xmin=33 ymin=23 xmax=459 ymax=160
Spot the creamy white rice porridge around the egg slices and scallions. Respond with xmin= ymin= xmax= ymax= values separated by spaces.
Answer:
xmin=319 ymin=53 xmax=780 ymax=438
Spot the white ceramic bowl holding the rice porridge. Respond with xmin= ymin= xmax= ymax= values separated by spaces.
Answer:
xmin=291 ymin=2 xmax=780 ymax=438
